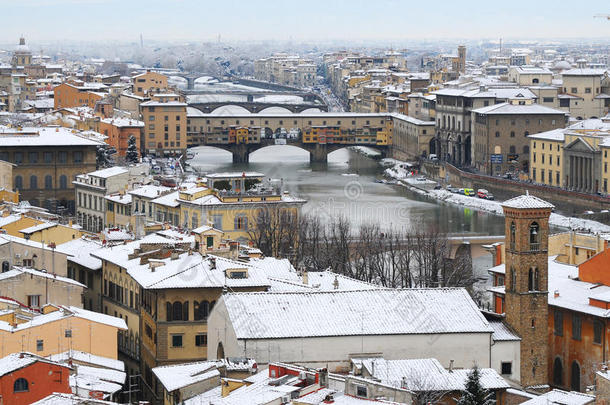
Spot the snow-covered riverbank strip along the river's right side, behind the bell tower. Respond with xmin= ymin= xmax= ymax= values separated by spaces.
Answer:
xmin=384 ymin=161 xmax=610 ymax=233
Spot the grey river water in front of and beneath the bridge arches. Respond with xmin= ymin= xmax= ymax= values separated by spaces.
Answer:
xmin=190 ymin=146 xmax=504 ymax=235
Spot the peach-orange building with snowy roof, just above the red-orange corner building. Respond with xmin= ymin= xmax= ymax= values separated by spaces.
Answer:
xmin=0 ymin=306 xmax=126 ymax=359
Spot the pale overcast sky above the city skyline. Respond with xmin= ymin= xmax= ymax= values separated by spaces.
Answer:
xmin=0 ymin=0 xmax=610 ymax=41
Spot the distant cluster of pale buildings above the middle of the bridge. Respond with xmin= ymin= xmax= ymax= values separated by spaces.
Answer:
xmin=254 ymin=53 xmax=318 ymax=88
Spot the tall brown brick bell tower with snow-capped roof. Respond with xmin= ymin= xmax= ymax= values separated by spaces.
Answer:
xmin=502 ymin=194 xmax=553 ymax=388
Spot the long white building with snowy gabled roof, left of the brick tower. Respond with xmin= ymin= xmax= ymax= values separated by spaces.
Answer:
xmin=208 ymin=288 xmax=518 ymax=371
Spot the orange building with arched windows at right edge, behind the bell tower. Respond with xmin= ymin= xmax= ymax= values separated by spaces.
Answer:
xmin=489 ymin=243 xmax=610 ymax=392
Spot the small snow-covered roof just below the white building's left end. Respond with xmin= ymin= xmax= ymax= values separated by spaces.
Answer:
xmin=152 ymin=361 xmax=220 ymax=392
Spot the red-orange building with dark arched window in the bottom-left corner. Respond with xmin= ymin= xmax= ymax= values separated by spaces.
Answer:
xmin=0 ymin=353 xmax=72 ymax=405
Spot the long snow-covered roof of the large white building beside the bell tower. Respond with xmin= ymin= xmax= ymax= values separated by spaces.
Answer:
xmin=222 ymin=288 xmax=493 ymax=339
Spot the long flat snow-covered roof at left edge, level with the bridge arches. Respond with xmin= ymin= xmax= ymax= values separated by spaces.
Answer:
xmin=0 ymin=126 xmax=102 ymax=147
